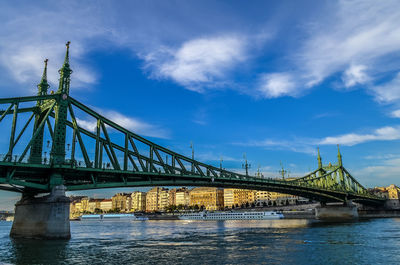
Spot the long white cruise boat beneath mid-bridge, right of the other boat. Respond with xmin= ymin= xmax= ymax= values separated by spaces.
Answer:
xmin=178 ymin=211 xmax=283 ymax=220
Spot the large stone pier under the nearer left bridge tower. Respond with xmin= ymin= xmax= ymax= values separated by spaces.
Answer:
xmin=10 ymin=185 xmax=71 ymax=239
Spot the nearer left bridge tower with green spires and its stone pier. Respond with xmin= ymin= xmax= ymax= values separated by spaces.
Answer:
xmin=10 ymin=42 xmax=72 ymax=239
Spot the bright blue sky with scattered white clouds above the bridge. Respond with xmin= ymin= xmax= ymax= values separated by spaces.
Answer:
xmin=0 ymin=1 xmax=400 ymax=208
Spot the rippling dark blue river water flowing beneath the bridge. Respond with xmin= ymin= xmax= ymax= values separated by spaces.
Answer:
xmin=0 ymin=218 xmax=400 ymax=265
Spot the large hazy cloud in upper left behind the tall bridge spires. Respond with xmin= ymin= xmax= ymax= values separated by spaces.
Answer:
xmin=0 ymin=2 xmax=107 ymax=93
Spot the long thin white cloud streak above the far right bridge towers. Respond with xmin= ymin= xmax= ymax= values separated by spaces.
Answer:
xmin=319 ymin=126 xmax=400 ymax=146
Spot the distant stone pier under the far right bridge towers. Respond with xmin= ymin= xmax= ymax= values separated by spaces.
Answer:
xmin=315 ymin=200 xmax=358 ymax=220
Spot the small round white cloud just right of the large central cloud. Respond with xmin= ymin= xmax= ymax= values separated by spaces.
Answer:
xmin=258 ymin=73 xmax=297 ymax=98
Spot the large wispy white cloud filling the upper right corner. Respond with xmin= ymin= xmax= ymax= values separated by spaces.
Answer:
xmin=300 ymin=1 xmax=400 ymax=82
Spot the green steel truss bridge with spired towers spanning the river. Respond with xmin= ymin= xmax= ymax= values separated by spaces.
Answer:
xmin=0 ymin=42 xmax=384 ymax=205
